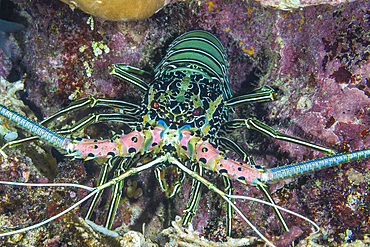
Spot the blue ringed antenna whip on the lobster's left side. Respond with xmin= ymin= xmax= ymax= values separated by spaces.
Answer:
xmin=0 ymin=105 xmax=70 ymax=150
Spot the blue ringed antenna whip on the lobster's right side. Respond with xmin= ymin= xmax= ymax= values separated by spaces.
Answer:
xmin=261 ymin=148 xmax=370 ymax=183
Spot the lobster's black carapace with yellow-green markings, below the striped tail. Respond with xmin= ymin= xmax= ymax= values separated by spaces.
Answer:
xmin=142 ymin=65 xmax=227 ymax=137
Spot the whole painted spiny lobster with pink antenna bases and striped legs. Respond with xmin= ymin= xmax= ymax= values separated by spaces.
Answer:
xmin=0 ymin=31 xmax=370 ymax=246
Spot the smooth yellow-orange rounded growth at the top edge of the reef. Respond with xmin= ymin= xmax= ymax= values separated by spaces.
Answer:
xmin=61 ymin=0 xmax=168 ymax=21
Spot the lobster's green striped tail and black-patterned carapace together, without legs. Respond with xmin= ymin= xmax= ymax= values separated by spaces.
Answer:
xmin=142 ymin=31 xmax=232 ymax=136
